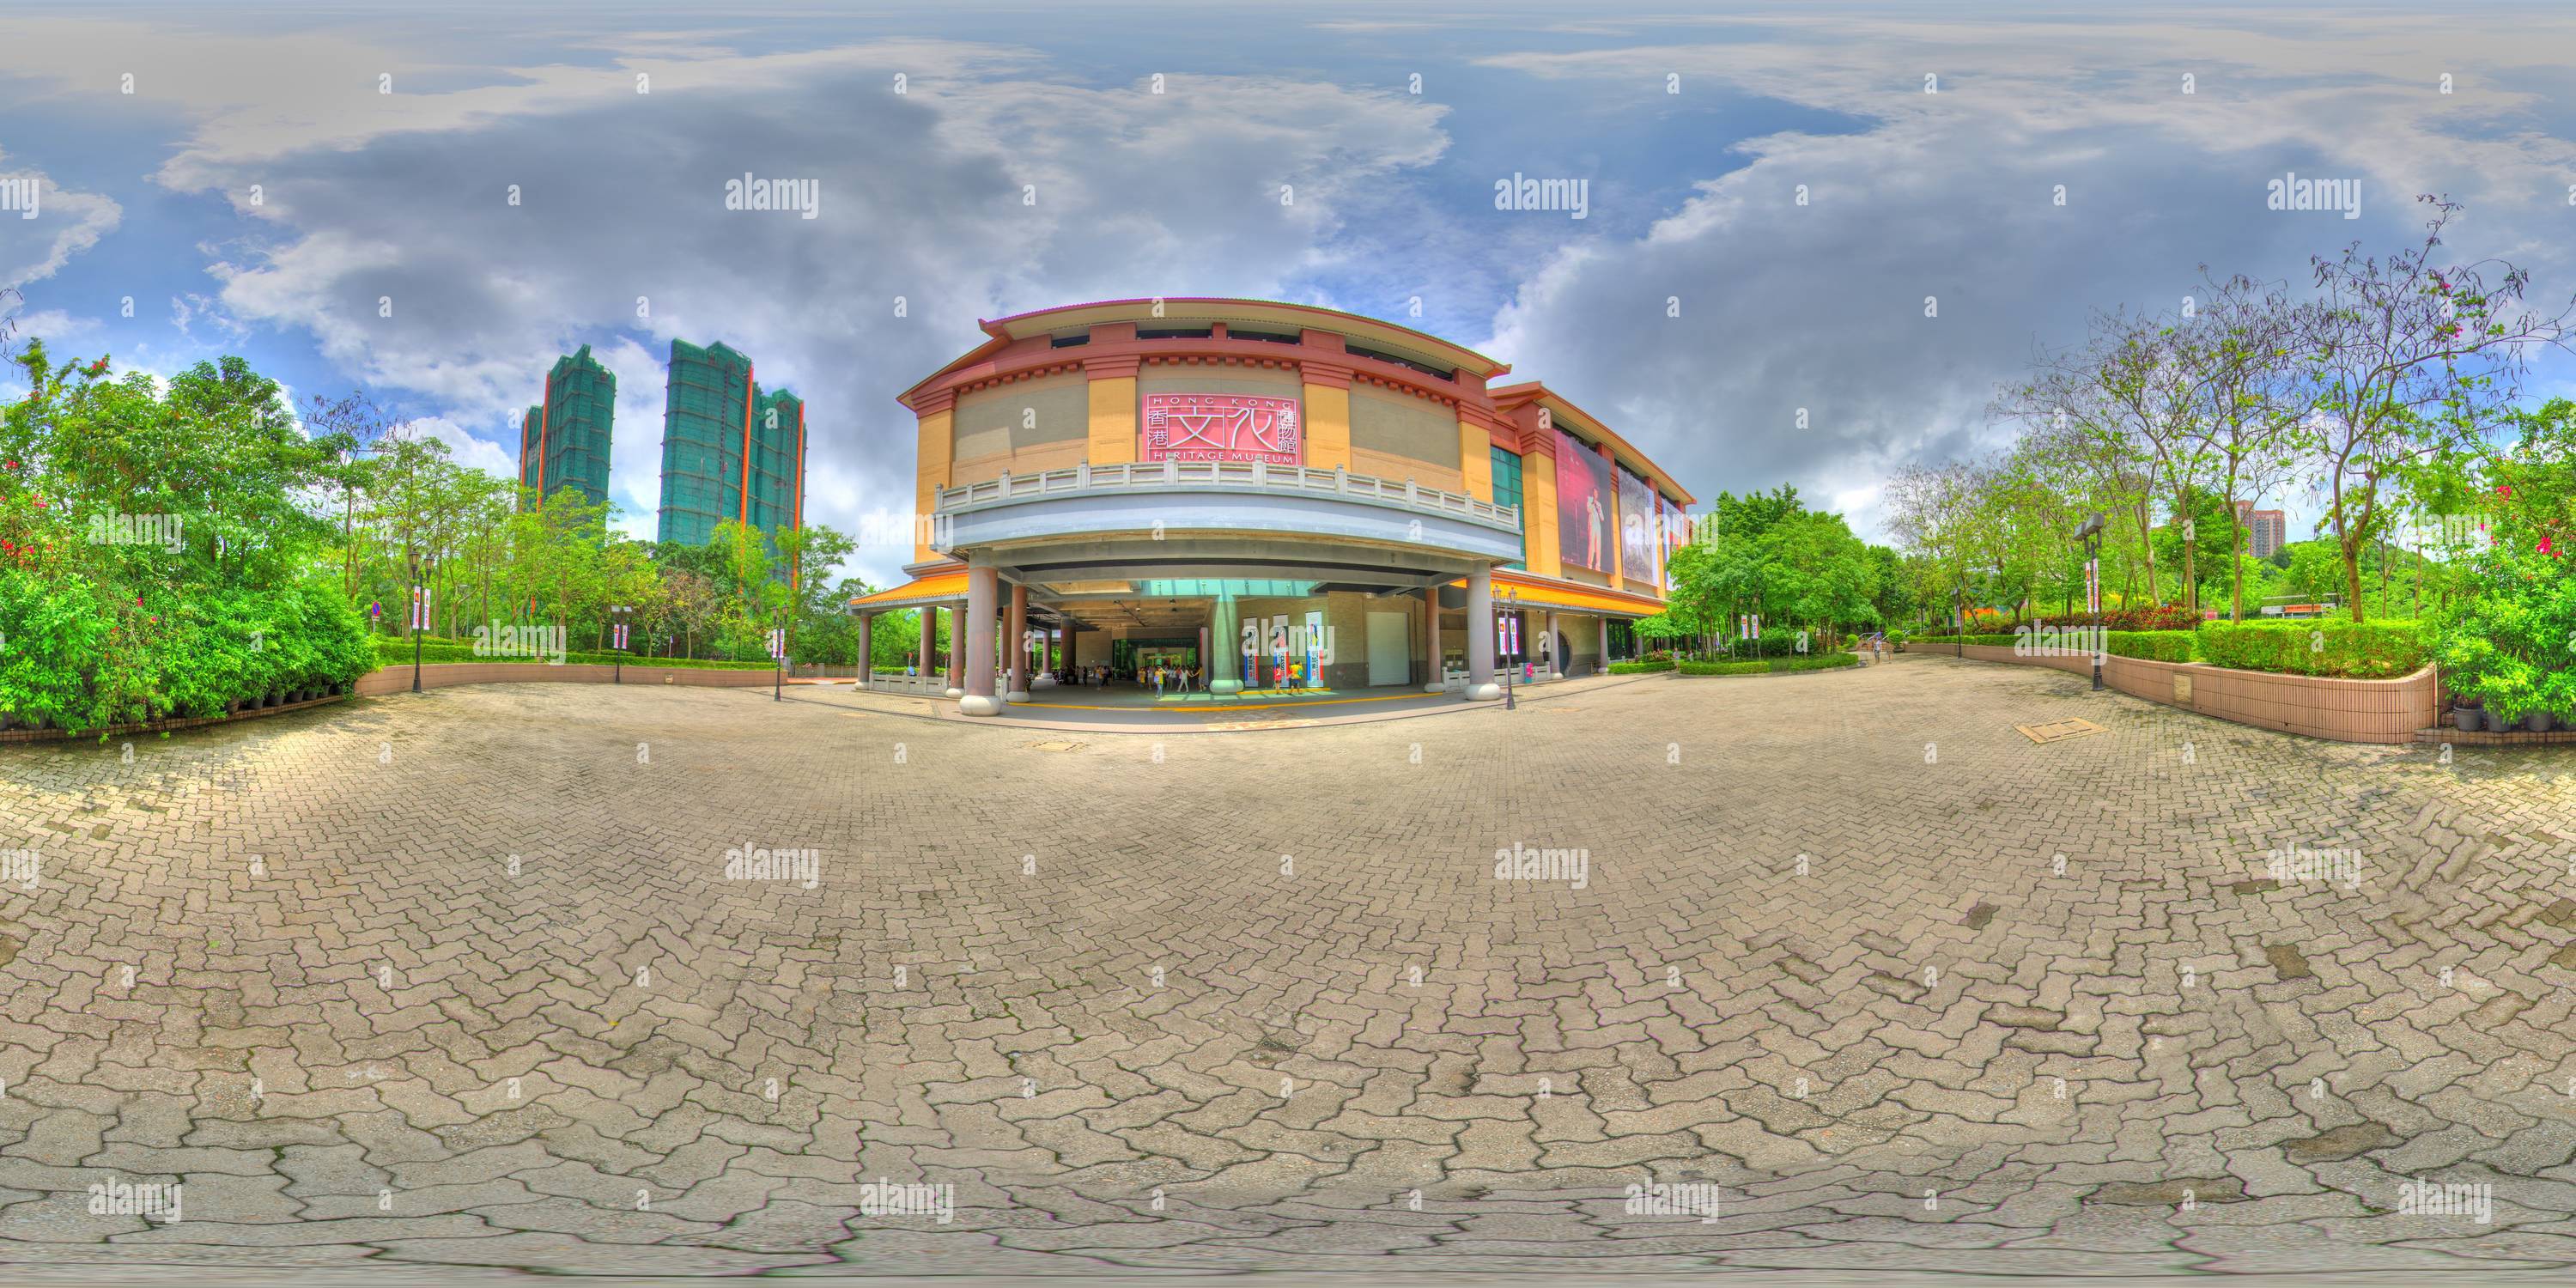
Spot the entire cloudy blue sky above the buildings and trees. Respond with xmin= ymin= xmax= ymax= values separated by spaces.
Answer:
xmin=0 ymin=3 xmax=2576 ymax=585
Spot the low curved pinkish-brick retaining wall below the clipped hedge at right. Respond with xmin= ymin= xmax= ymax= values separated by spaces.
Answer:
xmin=1922 ymin=644 xmax=2442 ymax=742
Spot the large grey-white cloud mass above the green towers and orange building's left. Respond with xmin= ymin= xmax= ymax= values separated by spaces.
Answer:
xmin=45 ymin=27 xmax=1445 ymax=580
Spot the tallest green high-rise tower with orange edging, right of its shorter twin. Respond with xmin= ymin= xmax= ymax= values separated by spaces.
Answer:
xmin=654 ymin=340 xmax=804 ymax=546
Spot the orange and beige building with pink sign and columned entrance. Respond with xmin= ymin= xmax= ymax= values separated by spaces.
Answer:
xmin=850 ymin=299 xmax=1692 ymax=714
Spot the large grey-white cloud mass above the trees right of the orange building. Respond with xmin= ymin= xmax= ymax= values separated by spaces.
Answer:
xmin=1484 ymin=10 xmax=2576 ymax=533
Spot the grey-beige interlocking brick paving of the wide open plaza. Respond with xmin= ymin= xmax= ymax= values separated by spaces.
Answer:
xmin=0 ymin=657 xmax=2576 ymax=1283
